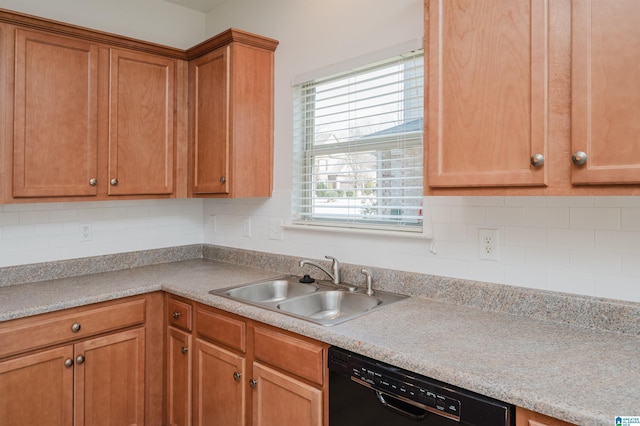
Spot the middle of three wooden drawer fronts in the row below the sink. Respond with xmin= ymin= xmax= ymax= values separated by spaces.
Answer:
xmin=196 ymin=308 xmax=247 ymax=353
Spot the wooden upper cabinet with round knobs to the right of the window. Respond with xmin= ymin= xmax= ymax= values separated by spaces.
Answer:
xmin=424 ymin=0 xmax=640 ymax=195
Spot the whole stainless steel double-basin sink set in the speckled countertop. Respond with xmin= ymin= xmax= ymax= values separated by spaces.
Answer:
xmin=209 ymin=275 xmax=407 ymax=326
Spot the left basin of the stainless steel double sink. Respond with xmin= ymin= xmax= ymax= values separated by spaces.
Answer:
xmin=226 ymin=278 xmax=318 ymax=303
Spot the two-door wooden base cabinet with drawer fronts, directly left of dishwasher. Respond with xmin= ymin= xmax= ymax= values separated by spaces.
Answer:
xmin=193 ymin=304 xmax=328 ymax=426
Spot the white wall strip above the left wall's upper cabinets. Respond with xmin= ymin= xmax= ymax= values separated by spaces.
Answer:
xmin=0 ymin=0 xmax=205 ymax=49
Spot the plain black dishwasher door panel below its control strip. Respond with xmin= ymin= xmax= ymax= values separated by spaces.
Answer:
xmin=329 ymin=371 xmax=460 ymax=426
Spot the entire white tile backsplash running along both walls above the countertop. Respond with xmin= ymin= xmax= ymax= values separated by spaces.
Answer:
xmin=0 ymin=195 xmax=640 ymax=301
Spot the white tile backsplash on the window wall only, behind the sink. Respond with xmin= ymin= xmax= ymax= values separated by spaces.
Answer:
xmin=204 ymin=195 xmax=640 ymax=301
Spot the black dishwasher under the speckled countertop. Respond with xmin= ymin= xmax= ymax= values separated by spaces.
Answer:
xmin=329 ymin=347 xmax=515 ymax=426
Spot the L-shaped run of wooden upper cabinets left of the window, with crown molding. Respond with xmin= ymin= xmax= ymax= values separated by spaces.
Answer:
xmin=0 ymin=9 xmax=278 ymax=203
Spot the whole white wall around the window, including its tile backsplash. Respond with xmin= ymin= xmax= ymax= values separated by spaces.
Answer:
xmin=204 ymin=0 xmax=640 ymax=301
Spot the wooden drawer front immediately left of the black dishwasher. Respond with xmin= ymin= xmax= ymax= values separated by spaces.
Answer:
xmin=254 ymin=327 xmax=325 ymax=385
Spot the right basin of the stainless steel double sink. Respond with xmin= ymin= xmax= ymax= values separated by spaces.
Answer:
xmin=277 ymin=290 xmax=382 ymax=320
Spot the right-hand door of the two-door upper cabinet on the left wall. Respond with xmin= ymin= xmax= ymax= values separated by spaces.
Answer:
xmin=109 ymin=50 xmax=176 ymax=195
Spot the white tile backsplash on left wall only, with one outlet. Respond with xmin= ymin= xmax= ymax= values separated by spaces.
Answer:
xmin=0 ymin=200 xmax=203 ymax=267
